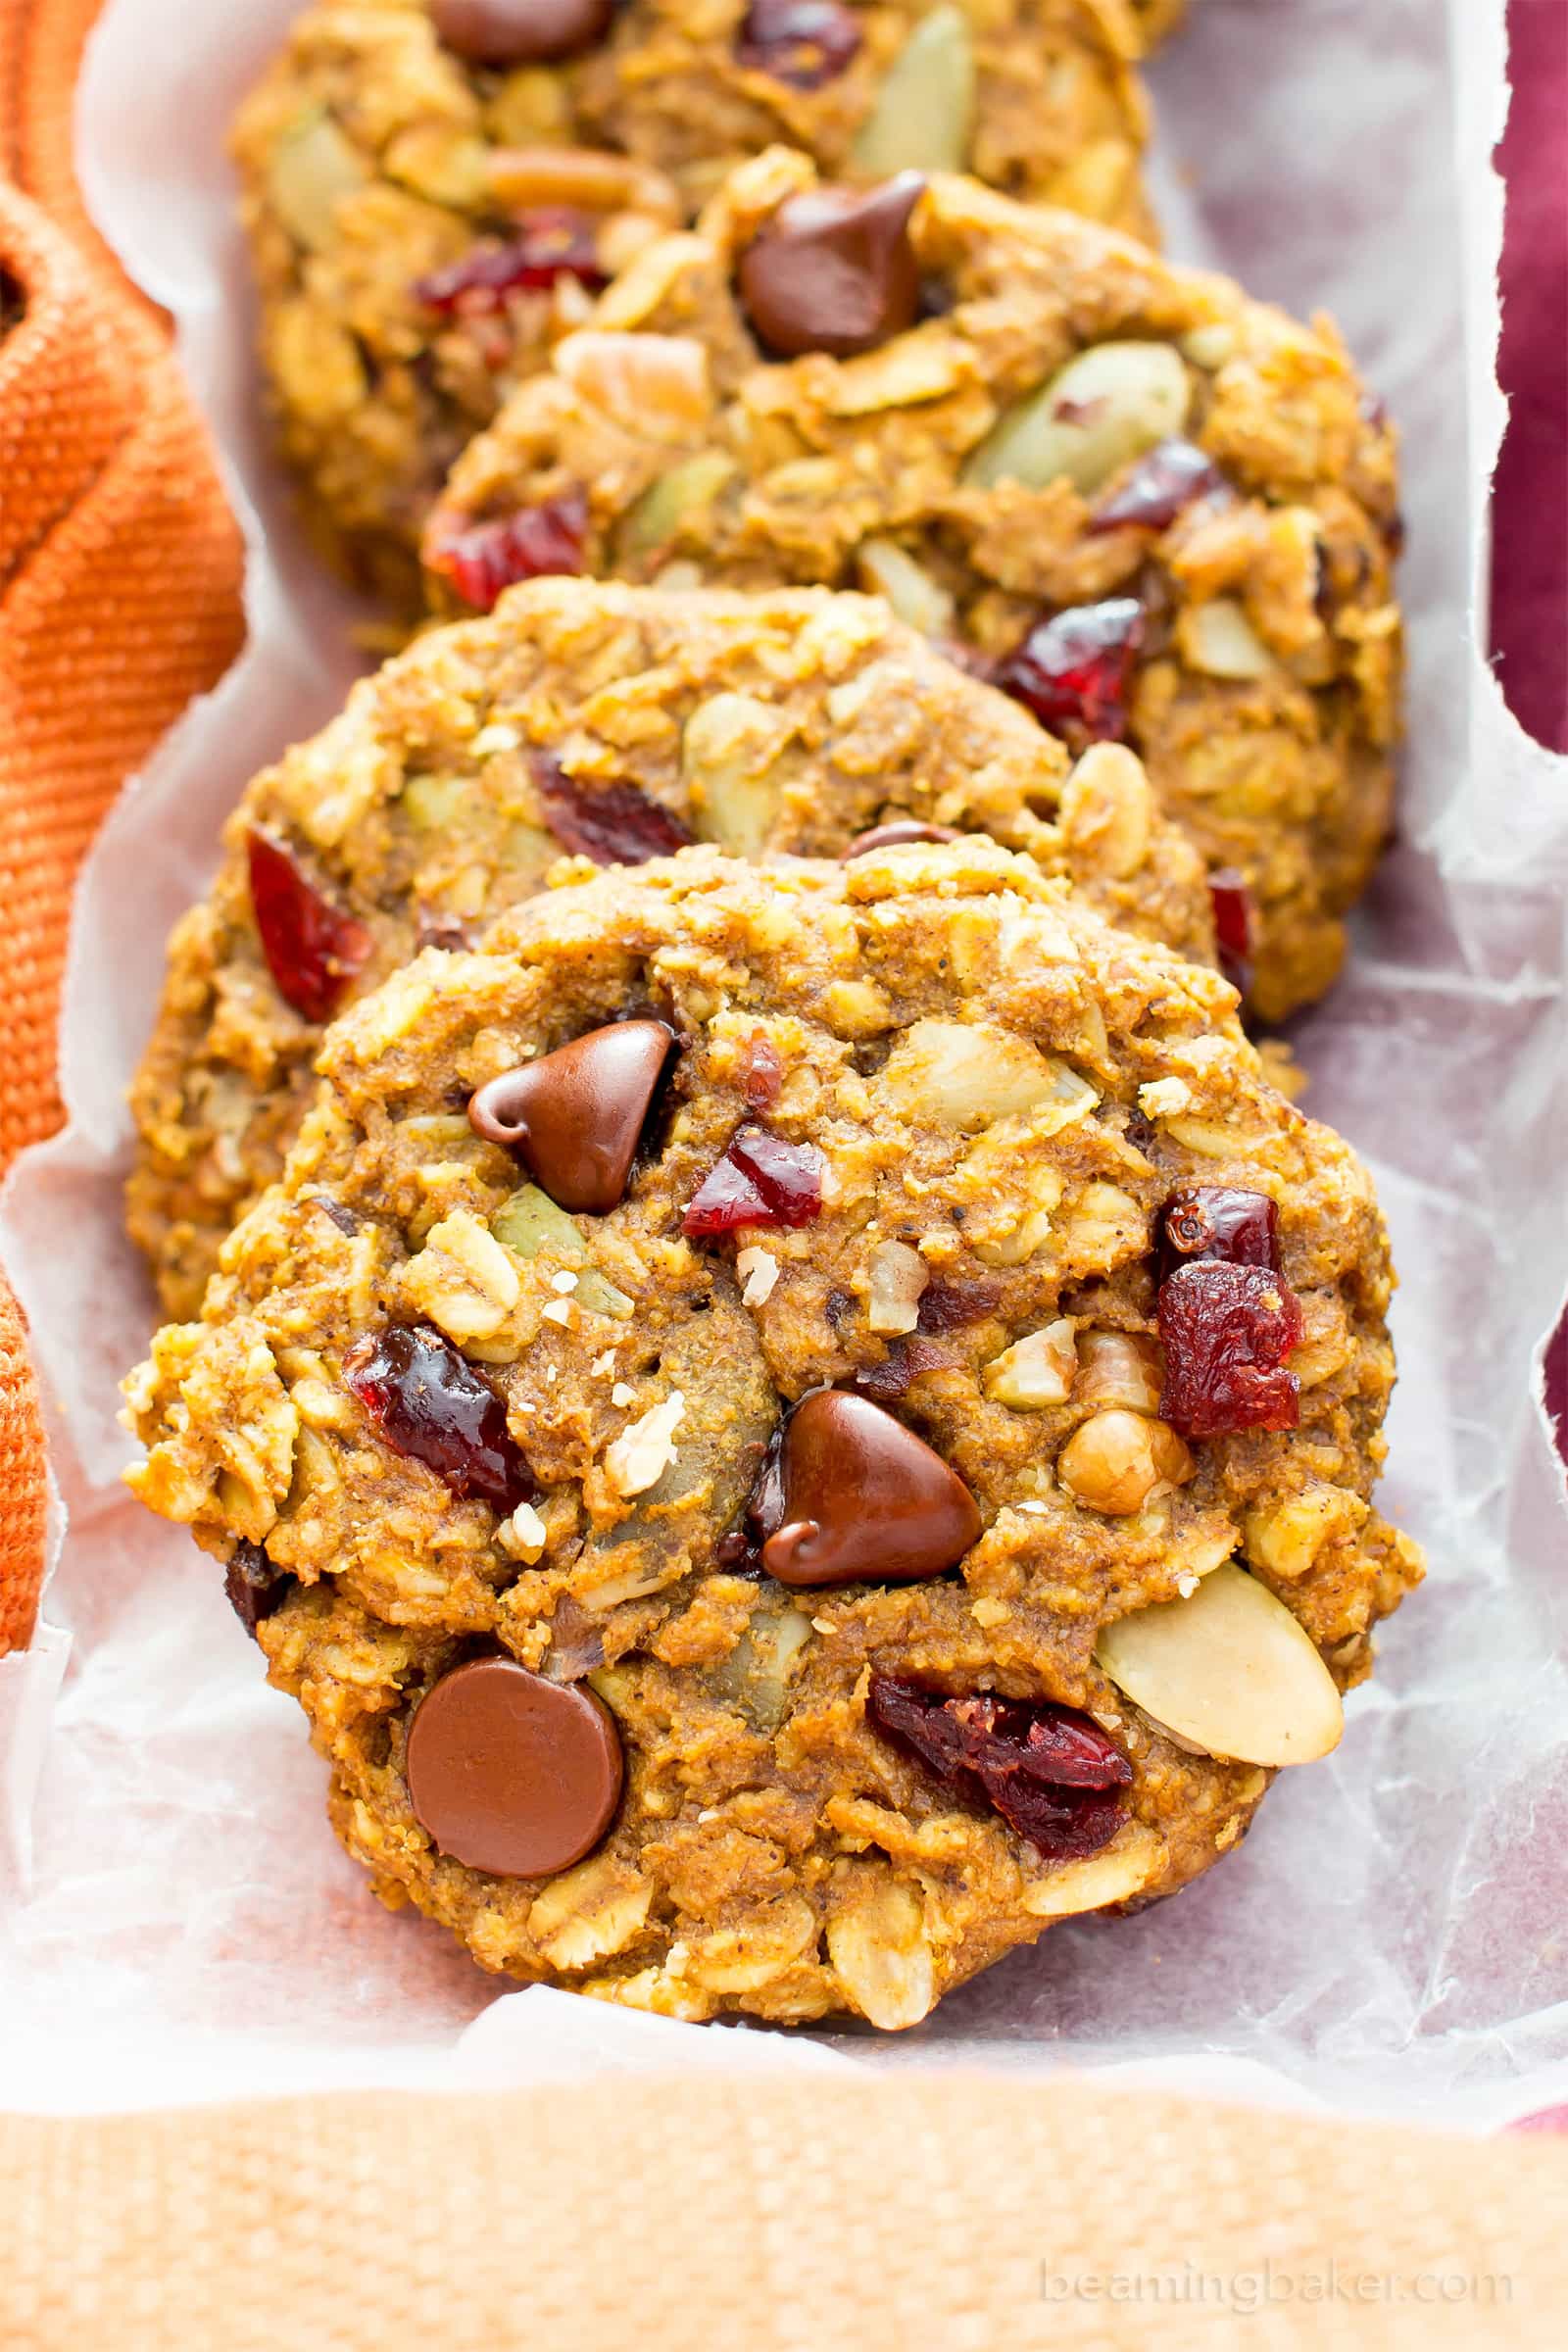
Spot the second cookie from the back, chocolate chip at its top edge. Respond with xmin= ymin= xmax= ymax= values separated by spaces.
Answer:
xmin=425 ymin=148 xmax=1401 ymax=1021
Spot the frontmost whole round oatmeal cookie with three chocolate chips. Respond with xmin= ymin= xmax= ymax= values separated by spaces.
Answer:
xmin=127 ymin=835 xmax=1420 ymax=2028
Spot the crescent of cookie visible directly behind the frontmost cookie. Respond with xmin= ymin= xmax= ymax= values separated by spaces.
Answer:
xmin=129 ymin=578 xmax=1213 ymax=1315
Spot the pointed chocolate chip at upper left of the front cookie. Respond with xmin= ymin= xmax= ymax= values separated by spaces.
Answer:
xmin=467 ymin=1021 xmax=674 ymax=1216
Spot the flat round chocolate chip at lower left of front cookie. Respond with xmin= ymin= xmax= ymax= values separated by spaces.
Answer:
xmin=405 ymin=1658 xmax=625 ymax=1880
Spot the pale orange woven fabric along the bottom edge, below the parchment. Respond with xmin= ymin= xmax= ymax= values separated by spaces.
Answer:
xmin=0 ymin=2075 xmax=1568 ymax=2352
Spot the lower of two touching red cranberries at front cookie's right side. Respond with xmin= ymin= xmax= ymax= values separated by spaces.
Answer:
xmin=1159 ymin=1258 xmax=1302 ymax=1437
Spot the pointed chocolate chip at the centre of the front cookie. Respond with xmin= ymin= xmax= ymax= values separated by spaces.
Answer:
xmin=761 ymin=1388 xmax=980 ymax=1588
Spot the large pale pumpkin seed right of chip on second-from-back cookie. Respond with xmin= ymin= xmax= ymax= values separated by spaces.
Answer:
xmin=964 ymin=343 xmax=1192 ymax=496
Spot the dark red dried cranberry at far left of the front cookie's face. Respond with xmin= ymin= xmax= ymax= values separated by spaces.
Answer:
xmin=343 ymin=1324 xmax=538 ymax=1510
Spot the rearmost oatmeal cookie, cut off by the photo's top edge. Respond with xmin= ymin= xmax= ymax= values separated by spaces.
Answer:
xmin=232 ymin=0 xmax=1150 ymax=610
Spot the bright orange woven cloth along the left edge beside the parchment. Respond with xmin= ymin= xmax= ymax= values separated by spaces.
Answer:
xmin=0 ymin=0 xmax=242 ymax=1651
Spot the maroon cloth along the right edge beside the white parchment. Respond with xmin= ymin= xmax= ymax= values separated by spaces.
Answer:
xmin=1493 ymin=0 xmax=1568 ymax=1463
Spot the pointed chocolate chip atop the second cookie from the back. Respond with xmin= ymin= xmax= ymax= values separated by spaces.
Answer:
xmin=738 ymin=172 xmax=926 ymax=360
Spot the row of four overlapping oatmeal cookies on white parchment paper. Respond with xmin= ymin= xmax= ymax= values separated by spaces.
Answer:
xmin=127 ymin=0 xmax=1420 ymax=2028
